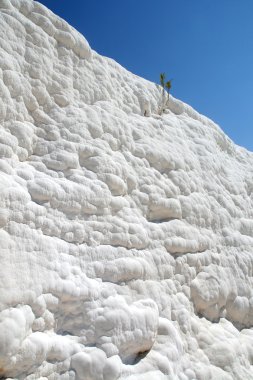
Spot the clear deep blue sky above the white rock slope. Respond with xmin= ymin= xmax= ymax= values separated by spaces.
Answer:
xmin=40 ymin=0 xmax=253 ymax=151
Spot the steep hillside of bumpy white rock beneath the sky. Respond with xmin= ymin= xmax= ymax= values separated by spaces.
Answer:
xmin=0 ymin=0 xmax=253 ymax=380
